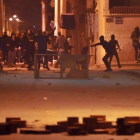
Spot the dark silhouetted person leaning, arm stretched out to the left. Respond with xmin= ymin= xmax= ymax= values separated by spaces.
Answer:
xmin=91 ymin=36 xmax=112 ymax=71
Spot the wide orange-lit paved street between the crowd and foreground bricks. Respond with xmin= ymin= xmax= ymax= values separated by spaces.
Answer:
xmin=0 ymin=65 xmax=140 ymax=140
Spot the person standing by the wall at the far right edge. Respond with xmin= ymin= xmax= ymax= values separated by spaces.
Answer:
xmin=131 ymin=27 xmax=140 ymax=62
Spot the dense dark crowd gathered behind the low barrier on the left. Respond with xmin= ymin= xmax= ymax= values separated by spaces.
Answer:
xmin=0 ymin=25 xmax=71 ymax=70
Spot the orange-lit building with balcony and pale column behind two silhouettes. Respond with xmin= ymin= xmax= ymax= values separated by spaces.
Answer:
xmin=87 ymin=0 xmax=140 ymax=65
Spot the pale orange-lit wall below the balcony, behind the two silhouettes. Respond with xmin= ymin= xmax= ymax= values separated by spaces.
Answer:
xmin=105 ymin=17 xmax=140 ymax=62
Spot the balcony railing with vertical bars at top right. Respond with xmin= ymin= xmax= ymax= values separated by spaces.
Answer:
xmin=110 ymin=6 xmax=140 ymax=15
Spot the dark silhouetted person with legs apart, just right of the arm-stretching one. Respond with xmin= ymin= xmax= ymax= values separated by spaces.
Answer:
xmin=109 ymin=35 xmax=121 ymax=68
